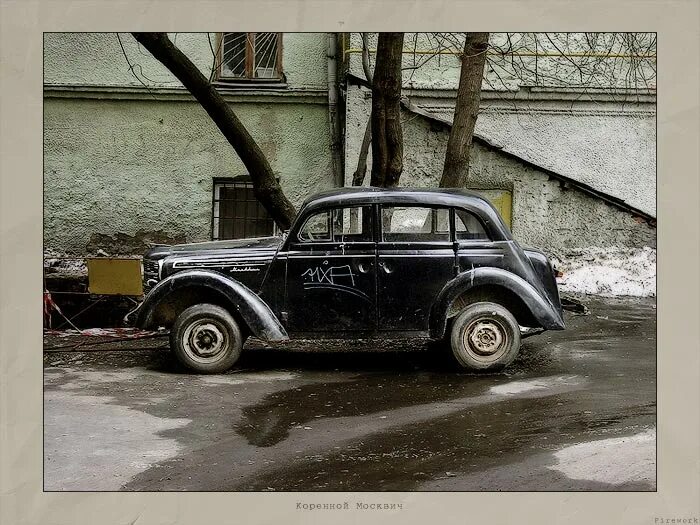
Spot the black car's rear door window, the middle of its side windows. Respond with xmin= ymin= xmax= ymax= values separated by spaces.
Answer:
xmin=382 ymin=206 xmax=450 ymax=242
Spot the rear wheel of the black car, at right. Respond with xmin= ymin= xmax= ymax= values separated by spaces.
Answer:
xmin=450 ymin=302 xmax=520 ymax=372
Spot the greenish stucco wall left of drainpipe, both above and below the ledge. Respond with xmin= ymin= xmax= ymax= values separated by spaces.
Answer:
xmin=44 ymin=33 xmax=334 ymax=255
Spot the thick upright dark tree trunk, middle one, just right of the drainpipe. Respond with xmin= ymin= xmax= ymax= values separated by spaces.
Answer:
xmin=371 ymin=33 xmax=403 ymax=188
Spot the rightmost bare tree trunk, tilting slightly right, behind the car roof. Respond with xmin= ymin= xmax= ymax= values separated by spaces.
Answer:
xmin=440 ymin=33 xmax=489 ymax=188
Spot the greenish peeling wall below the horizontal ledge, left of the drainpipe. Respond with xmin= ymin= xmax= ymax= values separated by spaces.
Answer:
xmin=44 ymin=98 xmax=333 ymax=254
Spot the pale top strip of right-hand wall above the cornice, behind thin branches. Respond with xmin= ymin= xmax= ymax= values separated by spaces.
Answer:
xmin=342 ymin=32 xmax=656 ymax=91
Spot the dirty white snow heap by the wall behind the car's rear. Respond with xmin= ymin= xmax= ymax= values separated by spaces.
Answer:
xmin=553 ymin=246 xmax=656 ymax=297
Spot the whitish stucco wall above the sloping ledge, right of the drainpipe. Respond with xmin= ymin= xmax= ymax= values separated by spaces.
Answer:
xmin=345 ymin=33 xmax=656 ymax=216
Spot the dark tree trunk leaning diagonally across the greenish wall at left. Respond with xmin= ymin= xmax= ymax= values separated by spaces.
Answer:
xmin=132 ymin=33 xmax=296 ymax=230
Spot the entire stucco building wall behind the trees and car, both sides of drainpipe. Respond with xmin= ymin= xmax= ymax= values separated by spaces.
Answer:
xmin=44 ymin=33 xmax=656 ymax=254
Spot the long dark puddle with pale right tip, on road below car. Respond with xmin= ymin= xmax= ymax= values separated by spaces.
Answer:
xmin=233 ymin=374 xmax=586 ymax=447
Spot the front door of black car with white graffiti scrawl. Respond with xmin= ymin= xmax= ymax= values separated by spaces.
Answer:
xmin=285 ymin=206 xmax=376 ymax=334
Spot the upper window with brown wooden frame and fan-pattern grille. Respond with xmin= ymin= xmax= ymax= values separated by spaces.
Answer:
xmin=218 ymin=33 xmax=282 ymax=80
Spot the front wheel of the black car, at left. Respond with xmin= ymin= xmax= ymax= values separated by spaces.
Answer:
xmin=170 ymin=304 xmax=244 ymax=374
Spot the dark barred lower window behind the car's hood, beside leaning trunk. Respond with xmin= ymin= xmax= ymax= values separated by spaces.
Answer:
xmin=212 ymin=177 xmax=275 ymax=241
